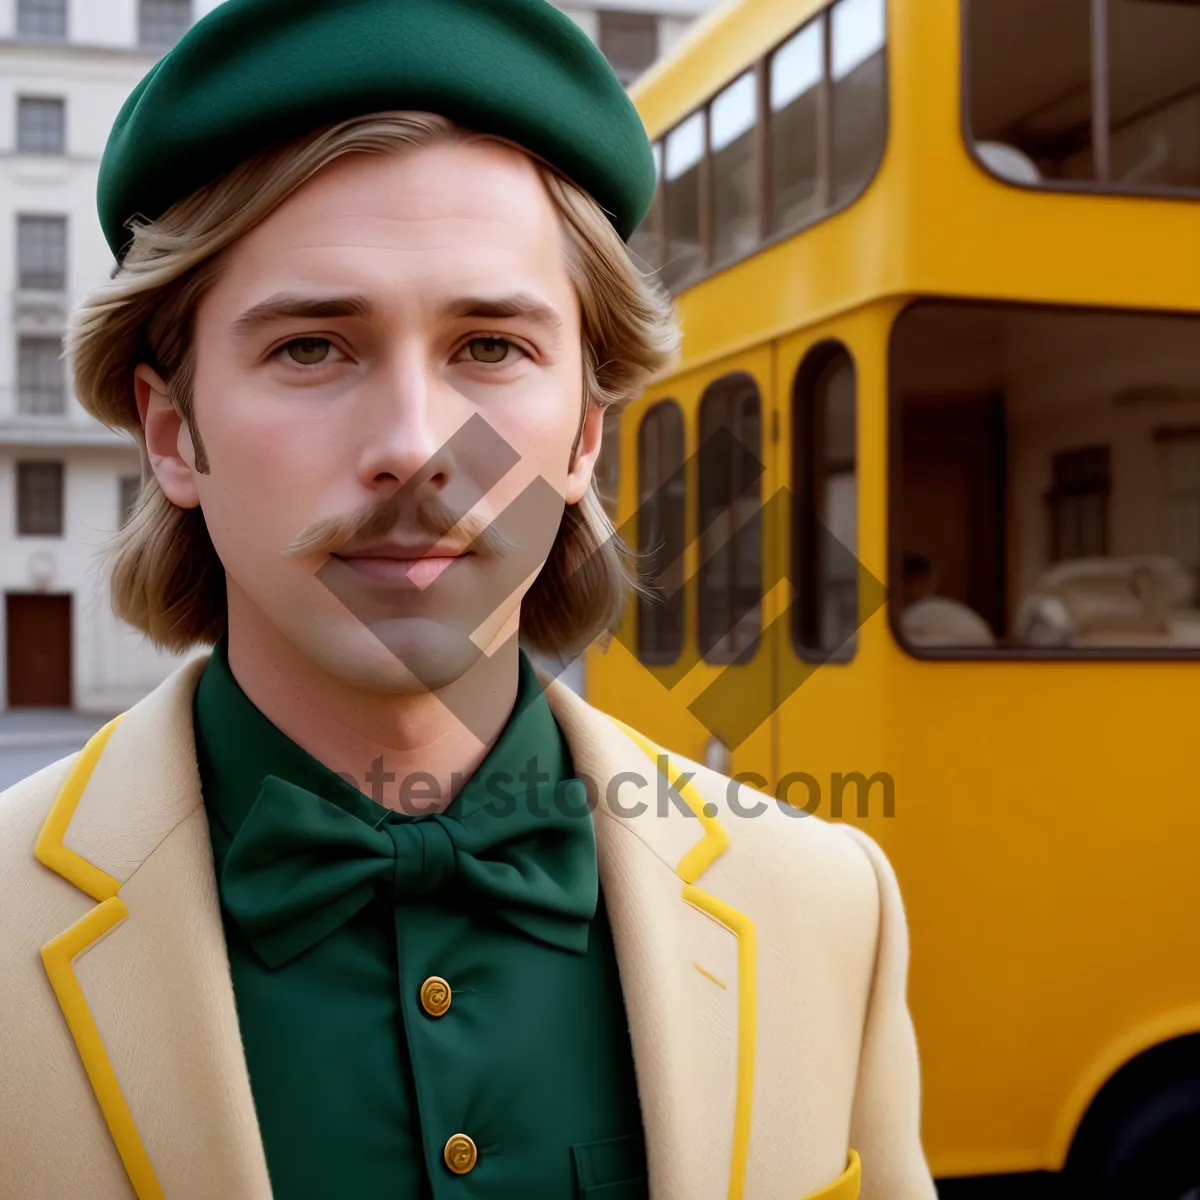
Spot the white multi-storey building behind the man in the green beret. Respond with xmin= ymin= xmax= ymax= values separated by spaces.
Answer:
xmin=0 ymin=0 xmax=714 ymax=713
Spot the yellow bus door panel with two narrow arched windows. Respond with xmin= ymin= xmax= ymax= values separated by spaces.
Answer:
xmin=604 ymin=349 xmax=782 ymax=772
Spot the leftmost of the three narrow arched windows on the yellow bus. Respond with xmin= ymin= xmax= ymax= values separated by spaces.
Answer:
xmin=637 ymin=400 xmax=686 ymax=665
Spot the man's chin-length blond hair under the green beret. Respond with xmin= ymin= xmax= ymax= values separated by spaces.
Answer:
xmin=67 ymin=113 xmax=678 ymax=658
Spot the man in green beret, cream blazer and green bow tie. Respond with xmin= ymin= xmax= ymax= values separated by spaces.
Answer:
xmin=0 ymin=0 xmax=932 ymax=1200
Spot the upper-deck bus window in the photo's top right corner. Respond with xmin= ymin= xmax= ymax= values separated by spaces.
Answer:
xmin=965 ymin=0 xmax=1200 ymax=191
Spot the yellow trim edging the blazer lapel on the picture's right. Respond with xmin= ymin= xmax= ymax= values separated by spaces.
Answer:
xmin=604 ymin=721 xmax=753 ymax=1200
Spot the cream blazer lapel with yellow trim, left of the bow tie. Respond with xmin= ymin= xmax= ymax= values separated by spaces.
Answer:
xmin=35 ymin=660 xmax=271 ymax=1200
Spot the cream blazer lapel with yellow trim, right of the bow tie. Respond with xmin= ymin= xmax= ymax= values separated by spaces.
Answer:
xmin=547 ymin=683 xmax=755 ymax=1200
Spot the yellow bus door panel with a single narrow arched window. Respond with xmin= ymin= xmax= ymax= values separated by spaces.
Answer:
xmin=770 ymin=310 xmax=887 ymax=818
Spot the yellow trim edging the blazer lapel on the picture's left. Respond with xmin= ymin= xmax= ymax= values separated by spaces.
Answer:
xmin=34 ymin=716 xmax=166 ymax=1200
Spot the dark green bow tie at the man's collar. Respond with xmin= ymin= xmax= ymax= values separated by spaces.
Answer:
xmin=221 ymin=775 xmax=599 ymax=968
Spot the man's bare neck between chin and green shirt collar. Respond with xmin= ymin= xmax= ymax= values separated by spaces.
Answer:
xmin=229 ymin=606 xmax=518 ymax=812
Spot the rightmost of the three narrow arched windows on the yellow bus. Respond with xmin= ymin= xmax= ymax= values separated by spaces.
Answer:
xmin=792 ymin=343 xmax=858 ymax=661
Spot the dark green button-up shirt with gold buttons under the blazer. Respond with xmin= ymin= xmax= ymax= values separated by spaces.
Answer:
xmin=194 ymin=643 xmax=647 ymax=1200
